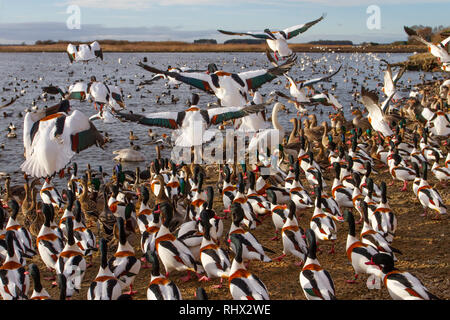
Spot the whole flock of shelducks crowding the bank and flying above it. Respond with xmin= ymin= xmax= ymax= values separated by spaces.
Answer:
xmin=0 ymin=16 xmax=450 ymax=300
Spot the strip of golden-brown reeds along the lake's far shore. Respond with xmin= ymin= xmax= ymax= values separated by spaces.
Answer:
xmin=0 ymin=41 xmax=426 ymax=52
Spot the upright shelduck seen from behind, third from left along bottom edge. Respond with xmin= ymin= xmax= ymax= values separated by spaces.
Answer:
xmin=55 ymin=217 xmax=86 ymax=298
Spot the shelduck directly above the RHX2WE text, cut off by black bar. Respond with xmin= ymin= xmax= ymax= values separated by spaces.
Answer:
xmin=228 ymin=234 xmax=269 ymax=300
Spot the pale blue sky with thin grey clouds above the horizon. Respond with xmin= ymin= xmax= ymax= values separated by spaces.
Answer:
xmin=0 ymin=0 xmax=450 ymax=43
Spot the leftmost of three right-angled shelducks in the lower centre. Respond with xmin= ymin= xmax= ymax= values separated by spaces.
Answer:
xmin=155 ymin=202 xmax=203 ymax=282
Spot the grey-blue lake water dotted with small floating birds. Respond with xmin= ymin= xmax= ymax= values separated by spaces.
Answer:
xmin=0 ymin=52 xmax=440 ymax=186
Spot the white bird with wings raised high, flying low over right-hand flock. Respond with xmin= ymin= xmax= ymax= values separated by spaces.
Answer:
xmin=361 ymin=87 xmax=394 ymax=137
